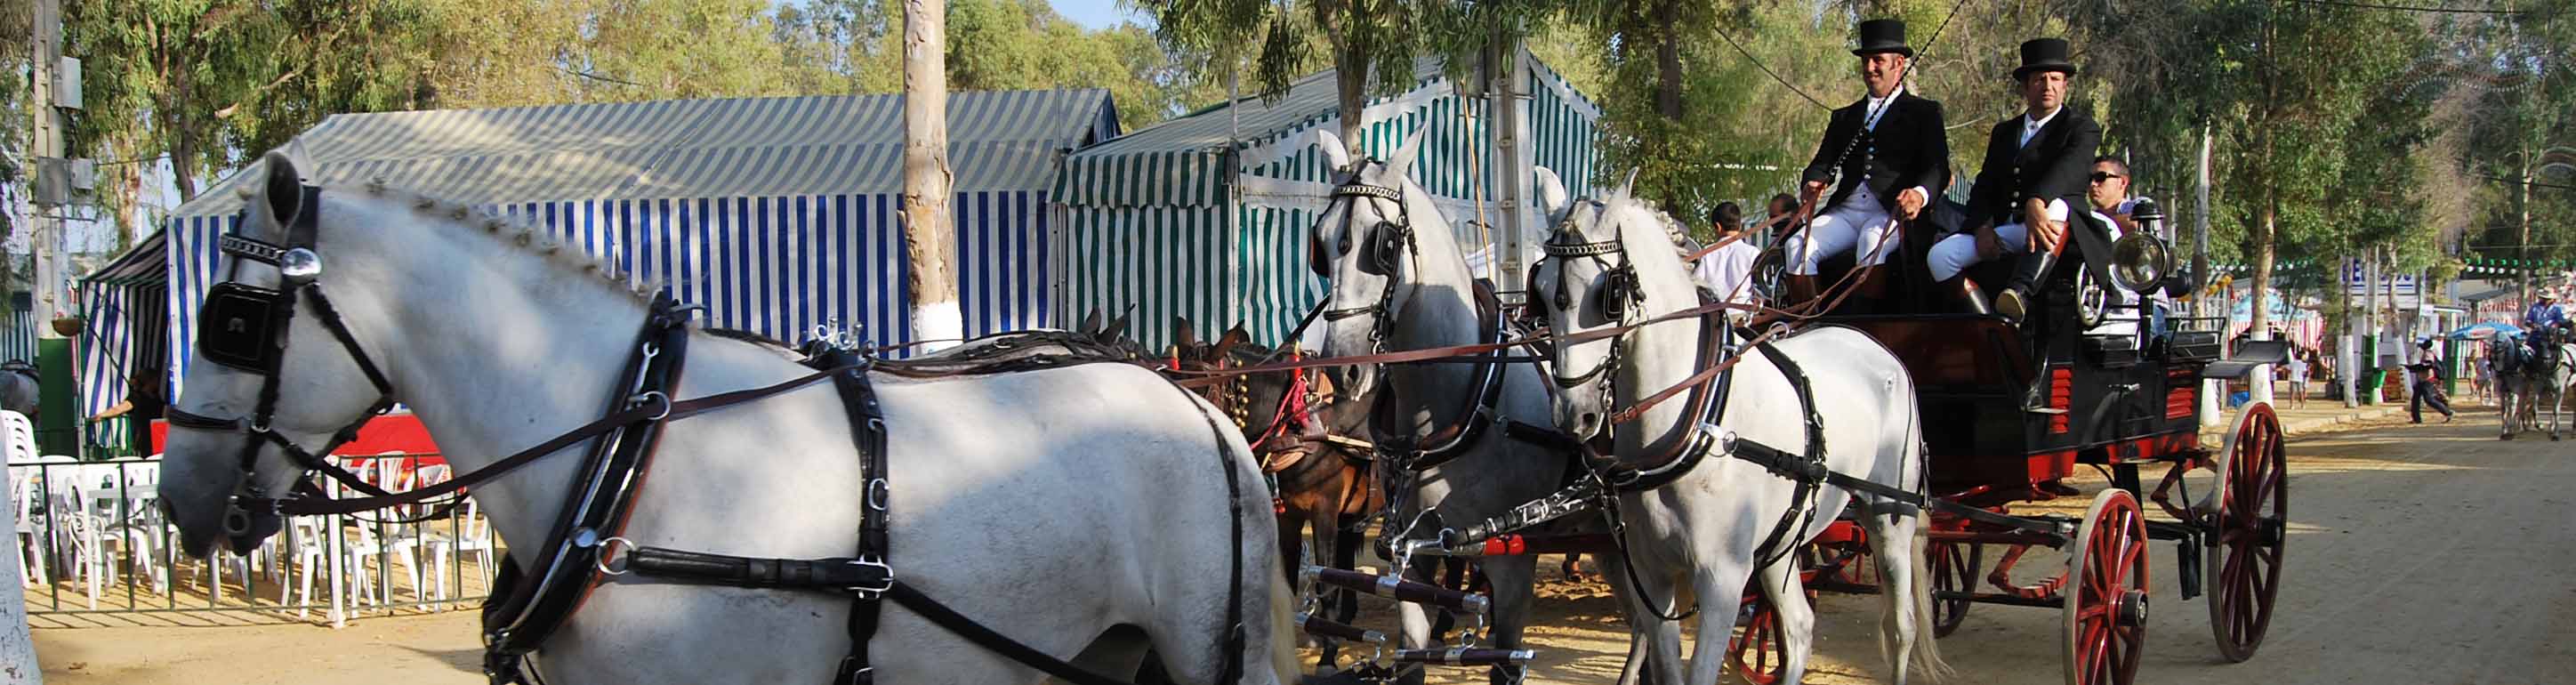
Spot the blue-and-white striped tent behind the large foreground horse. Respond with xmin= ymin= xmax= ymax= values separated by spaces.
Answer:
xmin=83 ymin=90 xmax=1118 ymax=440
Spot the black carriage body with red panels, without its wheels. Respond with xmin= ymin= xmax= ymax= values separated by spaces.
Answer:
xmin=1837 ymin=305 xmax=2216 ymax=502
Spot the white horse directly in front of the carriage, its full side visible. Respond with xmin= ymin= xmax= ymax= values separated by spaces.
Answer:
xmin=1530 ymin=170 xmax=1947 ymax=685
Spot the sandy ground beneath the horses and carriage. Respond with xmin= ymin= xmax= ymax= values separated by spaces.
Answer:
xmin=36 ymin=415 xmax=2576 ymax=685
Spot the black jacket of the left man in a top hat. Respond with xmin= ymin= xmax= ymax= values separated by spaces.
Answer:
xmin=1803 ymin=90 xmax=1950 ymax=211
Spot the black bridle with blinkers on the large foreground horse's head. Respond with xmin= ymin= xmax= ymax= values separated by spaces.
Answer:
xmin=162 ymin=185 xmax=394 ymax=538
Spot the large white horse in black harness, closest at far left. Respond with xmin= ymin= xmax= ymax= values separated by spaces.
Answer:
xmin=160 ymin=155 xmax=1296 ymax=682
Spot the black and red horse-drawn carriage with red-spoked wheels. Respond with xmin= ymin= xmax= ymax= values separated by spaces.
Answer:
xmin=1731 ymin=204 xmax=2288 ymax=685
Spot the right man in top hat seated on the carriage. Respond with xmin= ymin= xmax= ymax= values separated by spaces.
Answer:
xmin=1929 ymin=38 xmax=2102 ymax=322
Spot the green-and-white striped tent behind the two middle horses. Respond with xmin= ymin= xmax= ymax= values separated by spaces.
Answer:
xmin=1056 ymin=52 xmax=1599 ymax=345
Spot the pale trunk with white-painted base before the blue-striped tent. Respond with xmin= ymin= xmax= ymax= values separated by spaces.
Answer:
xmin=902 ymin=0 xmax=966 ymax=351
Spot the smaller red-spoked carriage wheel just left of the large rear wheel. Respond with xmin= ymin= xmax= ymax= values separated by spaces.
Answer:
xmin=2066 ymin=489 xmax=2145 ymax=685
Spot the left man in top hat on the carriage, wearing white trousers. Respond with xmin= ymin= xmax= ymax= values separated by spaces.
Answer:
xmin=1780 ymin=18 xmax=1950 ymax=306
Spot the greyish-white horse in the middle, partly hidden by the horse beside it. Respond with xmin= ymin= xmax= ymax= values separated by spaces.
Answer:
xmin=1308 ymin=132 xmax=1670 ymax=682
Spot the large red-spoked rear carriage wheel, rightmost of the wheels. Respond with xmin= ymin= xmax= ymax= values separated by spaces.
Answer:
xmin=2205 ymin=404 xmax=2290 ymax=662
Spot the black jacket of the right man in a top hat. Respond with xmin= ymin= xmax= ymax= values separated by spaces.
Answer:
xmin=1963 ymin=109 xmax=2102 ymax=227
